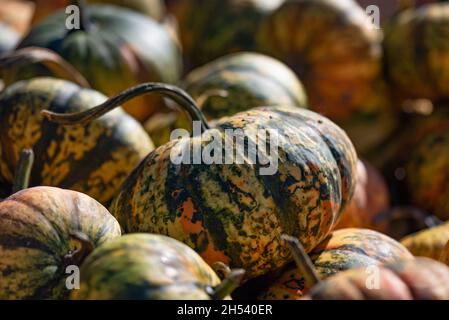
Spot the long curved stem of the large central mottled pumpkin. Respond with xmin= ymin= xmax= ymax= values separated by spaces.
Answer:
xmin=42 ymin=82 xmax=210 ymax=132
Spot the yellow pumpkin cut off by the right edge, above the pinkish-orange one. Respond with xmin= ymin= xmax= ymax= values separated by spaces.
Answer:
xmin=401 ymin=223 xmax=449 ymax=260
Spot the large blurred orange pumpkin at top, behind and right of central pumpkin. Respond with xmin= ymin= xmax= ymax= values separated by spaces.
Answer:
xmin=257 ymin=0 xmax=382 ymax=121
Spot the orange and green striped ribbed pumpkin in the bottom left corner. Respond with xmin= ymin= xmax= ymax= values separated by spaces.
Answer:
xmin=0 ymin=187 xmax=120 ymax=299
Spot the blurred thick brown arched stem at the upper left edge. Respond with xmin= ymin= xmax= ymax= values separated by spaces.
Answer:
xmin=0 ymin=47 xmax=90 ymax=88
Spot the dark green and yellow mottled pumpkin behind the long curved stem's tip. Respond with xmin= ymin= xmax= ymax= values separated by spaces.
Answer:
xmin=0 ymin=78 xmax=153 ymax=203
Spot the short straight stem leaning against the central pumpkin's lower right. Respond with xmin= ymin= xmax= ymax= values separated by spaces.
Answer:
xmin=281 ymin=235 xmax=321 ymax=288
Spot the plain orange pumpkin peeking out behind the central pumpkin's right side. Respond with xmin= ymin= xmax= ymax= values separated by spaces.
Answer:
xmin=335 ymin=161 xmax=390 ymax=229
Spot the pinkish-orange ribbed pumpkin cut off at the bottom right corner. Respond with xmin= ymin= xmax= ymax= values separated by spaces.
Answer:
xmin=304 ymin=258 xmax=449 ymax=300
